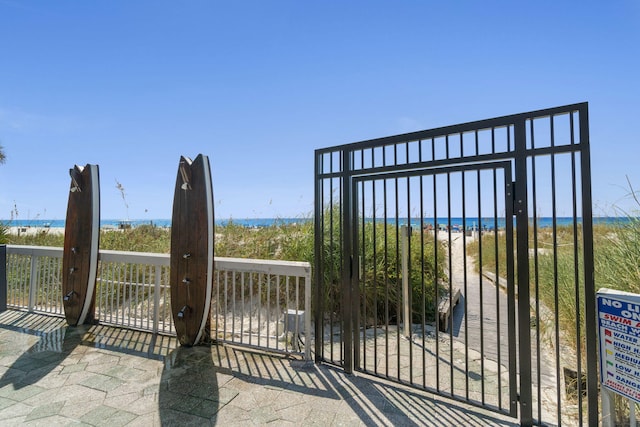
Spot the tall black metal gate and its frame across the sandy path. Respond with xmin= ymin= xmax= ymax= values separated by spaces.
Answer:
xmin=315 ymin=103 xmax=598 ymax=425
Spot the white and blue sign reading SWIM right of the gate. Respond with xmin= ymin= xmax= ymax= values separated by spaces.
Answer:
xmin=596 ymin=289 xmax=640 ymax=403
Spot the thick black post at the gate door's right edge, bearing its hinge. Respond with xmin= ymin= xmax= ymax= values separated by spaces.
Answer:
xmin=514 ymin=119 xmax=533 ymax=425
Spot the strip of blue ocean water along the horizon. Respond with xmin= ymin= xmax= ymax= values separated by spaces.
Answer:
xmin=0 ymin=217 xmax=638 ymax=230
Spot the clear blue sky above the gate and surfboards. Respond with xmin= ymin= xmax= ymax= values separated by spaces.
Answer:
xmin=0 ymin=0 xmax=640 ymax=219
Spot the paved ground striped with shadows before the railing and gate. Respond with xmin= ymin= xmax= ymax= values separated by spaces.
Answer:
xmin=0 ymin=312 xmax=517 ymax=426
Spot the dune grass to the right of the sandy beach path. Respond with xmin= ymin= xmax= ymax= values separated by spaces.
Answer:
xmin=468 ymin=217 xmax=640 ymax=343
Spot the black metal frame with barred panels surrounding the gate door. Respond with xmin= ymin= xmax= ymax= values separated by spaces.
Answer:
xmin=314 ymin=103 xmax=598 ymax=425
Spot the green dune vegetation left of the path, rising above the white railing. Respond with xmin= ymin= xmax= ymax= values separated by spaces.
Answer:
xmin=9 ymin=217 xmax=445 ymax=321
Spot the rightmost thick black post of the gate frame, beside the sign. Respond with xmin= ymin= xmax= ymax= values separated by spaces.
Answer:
xmin=572 ymin=104 xmax=598 ymax=425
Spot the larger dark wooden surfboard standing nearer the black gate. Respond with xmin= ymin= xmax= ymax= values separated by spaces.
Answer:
xmin=170 ymin=154 xmax=214 ymax=346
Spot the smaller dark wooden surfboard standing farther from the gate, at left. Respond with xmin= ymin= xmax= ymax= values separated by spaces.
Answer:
xmin=62 ymin=164 xmax=100 ymax=326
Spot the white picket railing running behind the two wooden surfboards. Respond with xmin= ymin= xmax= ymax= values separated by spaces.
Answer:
xmin=6 ymin=245 xmax=312 ymax=359
